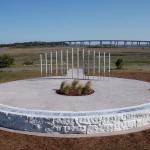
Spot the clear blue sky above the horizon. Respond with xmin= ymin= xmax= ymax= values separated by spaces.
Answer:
xmin=0 ymin=0 xmax=150 ymax=44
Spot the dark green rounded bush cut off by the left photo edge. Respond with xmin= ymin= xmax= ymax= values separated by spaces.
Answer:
xmin=0 ymin=54 xmax=14 ymax=68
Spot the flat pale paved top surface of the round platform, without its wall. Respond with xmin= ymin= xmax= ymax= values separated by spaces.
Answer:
xmin=0 ymin=78 xmax=150 ymax=111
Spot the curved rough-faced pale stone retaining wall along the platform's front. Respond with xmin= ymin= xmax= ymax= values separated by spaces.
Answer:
xmin=0 ymin=104 xmax=150 ymax=134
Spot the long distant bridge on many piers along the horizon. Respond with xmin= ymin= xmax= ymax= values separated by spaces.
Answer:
xmin=50 ymin=40 xmax=150 ymax=48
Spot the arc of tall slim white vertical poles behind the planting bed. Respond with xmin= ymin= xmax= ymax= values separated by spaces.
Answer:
xmin=40 ymin=48 xmax=111 ymax=79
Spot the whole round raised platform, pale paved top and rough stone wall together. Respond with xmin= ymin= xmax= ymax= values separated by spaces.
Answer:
xmin=0 ymin=77 xmax=150 ymax=136
